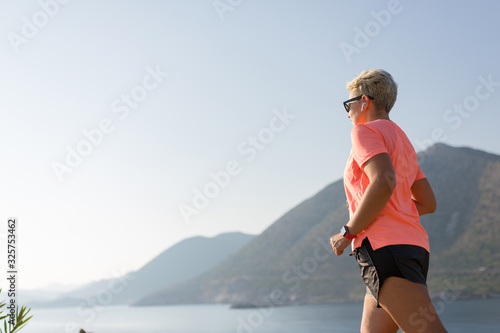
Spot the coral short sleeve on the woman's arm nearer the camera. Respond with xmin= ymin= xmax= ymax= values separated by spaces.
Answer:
xmin=351 ymin=124 xmax=388 ymax=168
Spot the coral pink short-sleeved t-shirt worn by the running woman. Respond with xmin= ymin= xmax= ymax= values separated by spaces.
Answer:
xmin=344 ymin=119 xmax=430 ymax=252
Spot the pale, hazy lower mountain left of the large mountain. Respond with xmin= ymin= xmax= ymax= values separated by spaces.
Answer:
xmin=35 ymin=232 xmax=255 ymax=307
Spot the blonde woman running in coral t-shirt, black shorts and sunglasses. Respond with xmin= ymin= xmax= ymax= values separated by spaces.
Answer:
xmin=330 ymin=69 xmax=447 ymax=333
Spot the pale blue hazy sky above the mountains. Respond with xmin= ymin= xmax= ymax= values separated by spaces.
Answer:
xmin=0 ymin=0 xmax=500 ymax=289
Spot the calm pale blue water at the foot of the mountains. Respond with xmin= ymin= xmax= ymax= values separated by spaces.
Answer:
xmin=21 ymin=299 xmax=500 ymax=333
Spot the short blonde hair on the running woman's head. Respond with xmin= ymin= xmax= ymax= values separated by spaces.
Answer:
xmin=347 ymin=69 xmax=398 ymax=112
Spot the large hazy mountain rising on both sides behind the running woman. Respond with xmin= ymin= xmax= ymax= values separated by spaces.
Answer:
xmin=134 ymin=144 xmax=500 ymax=306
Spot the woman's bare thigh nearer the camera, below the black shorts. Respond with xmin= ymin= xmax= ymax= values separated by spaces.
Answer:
xmin=379 ymin=277 xmax=447 ymax=333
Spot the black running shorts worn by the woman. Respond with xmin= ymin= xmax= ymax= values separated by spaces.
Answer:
xmin=354 ymin=238 xmax=429 ymax=308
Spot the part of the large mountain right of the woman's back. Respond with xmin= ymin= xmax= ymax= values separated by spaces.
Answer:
xmin=414 ymin=144 xmax=500 ymax=296
